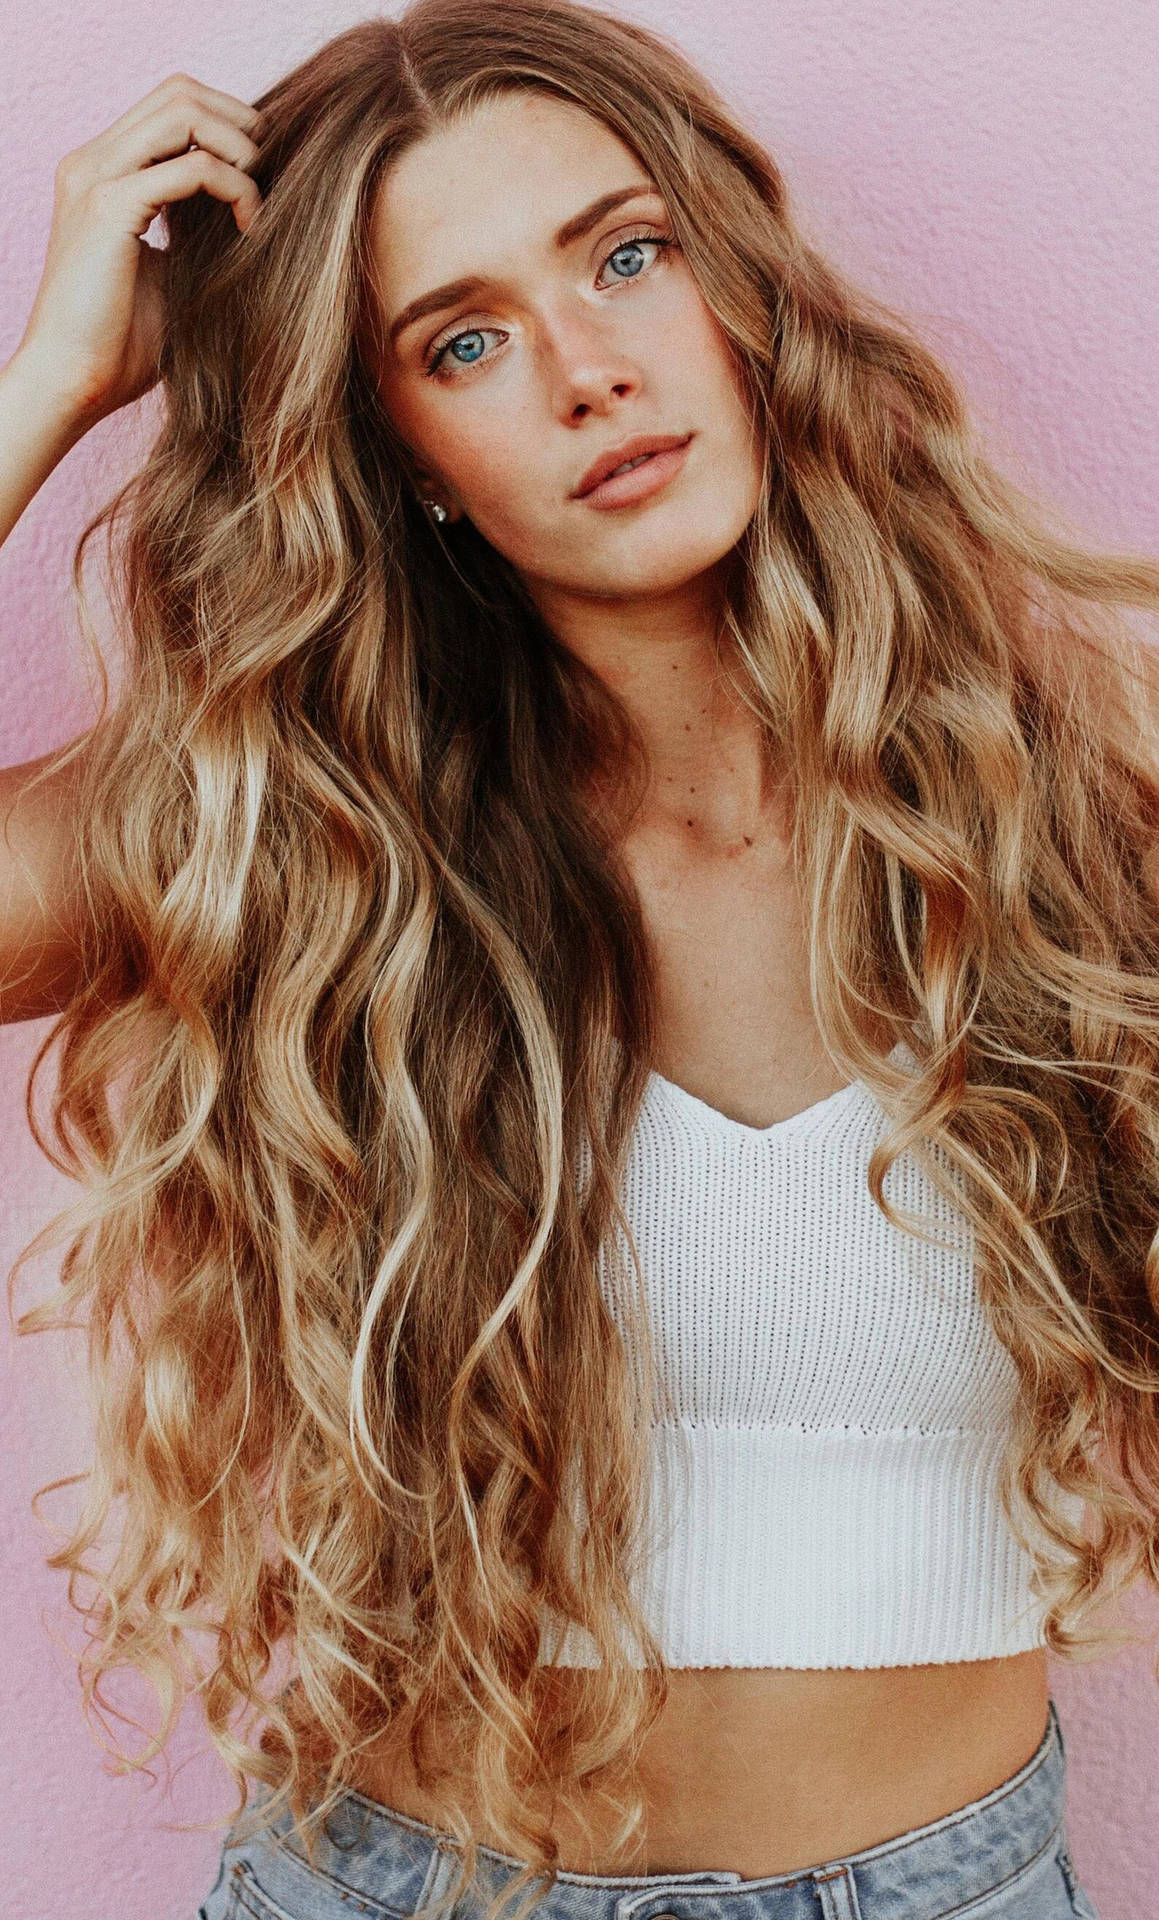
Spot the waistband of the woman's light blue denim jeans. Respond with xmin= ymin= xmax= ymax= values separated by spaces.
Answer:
xmin=253 ymin=1699 xmax=1065 ymax=1920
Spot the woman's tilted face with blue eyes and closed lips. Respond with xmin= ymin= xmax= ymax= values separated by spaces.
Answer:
xmin=362 ymin=92 xmax=762 ymax=601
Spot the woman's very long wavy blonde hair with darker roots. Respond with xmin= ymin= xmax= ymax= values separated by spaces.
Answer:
xmin=13 ymin=0 xmax=1159 ymax=1916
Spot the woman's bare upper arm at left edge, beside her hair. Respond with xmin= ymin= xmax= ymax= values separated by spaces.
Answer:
xmin=0 ymin=735 xmax=100 ymax=1023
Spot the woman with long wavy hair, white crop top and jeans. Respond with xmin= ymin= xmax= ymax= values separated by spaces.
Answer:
xmin=0 ymin=0 xmax=1159 ymax=1920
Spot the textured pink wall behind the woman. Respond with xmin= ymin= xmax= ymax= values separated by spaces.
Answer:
xmin=0 ymin=0 xmax=1159 ymax=1920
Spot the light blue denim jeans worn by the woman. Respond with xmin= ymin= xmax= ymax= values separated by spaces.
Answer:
xmin=198 ymin=1699 xmax=1100 ymax=1920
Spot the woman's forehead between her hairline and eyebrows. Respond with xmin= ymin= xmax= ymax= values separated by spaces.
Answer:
xmin=370 ymin=92 xmax=647 ymax=295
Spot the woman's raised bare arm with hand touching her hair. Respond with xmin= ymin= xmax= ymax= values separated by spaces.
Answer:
xmin=0 ymin=73 xmax=261 ymax=1021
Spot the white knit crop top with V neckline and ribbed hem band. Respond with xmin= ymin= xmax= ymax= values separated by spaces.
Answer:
xmin=539 ymin=1043 xmax=1082 ymax=1667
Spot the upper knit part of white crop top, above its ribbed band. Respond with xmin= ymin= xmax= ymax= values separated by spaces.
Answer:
xmin=608 ymin=1081 xmax=1013 ymax=1432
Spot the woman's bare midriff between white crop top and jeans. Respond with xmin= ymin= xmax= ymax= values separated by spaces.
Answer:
xmin=343 ymin=1647 xmax=1050 ymax=1880
